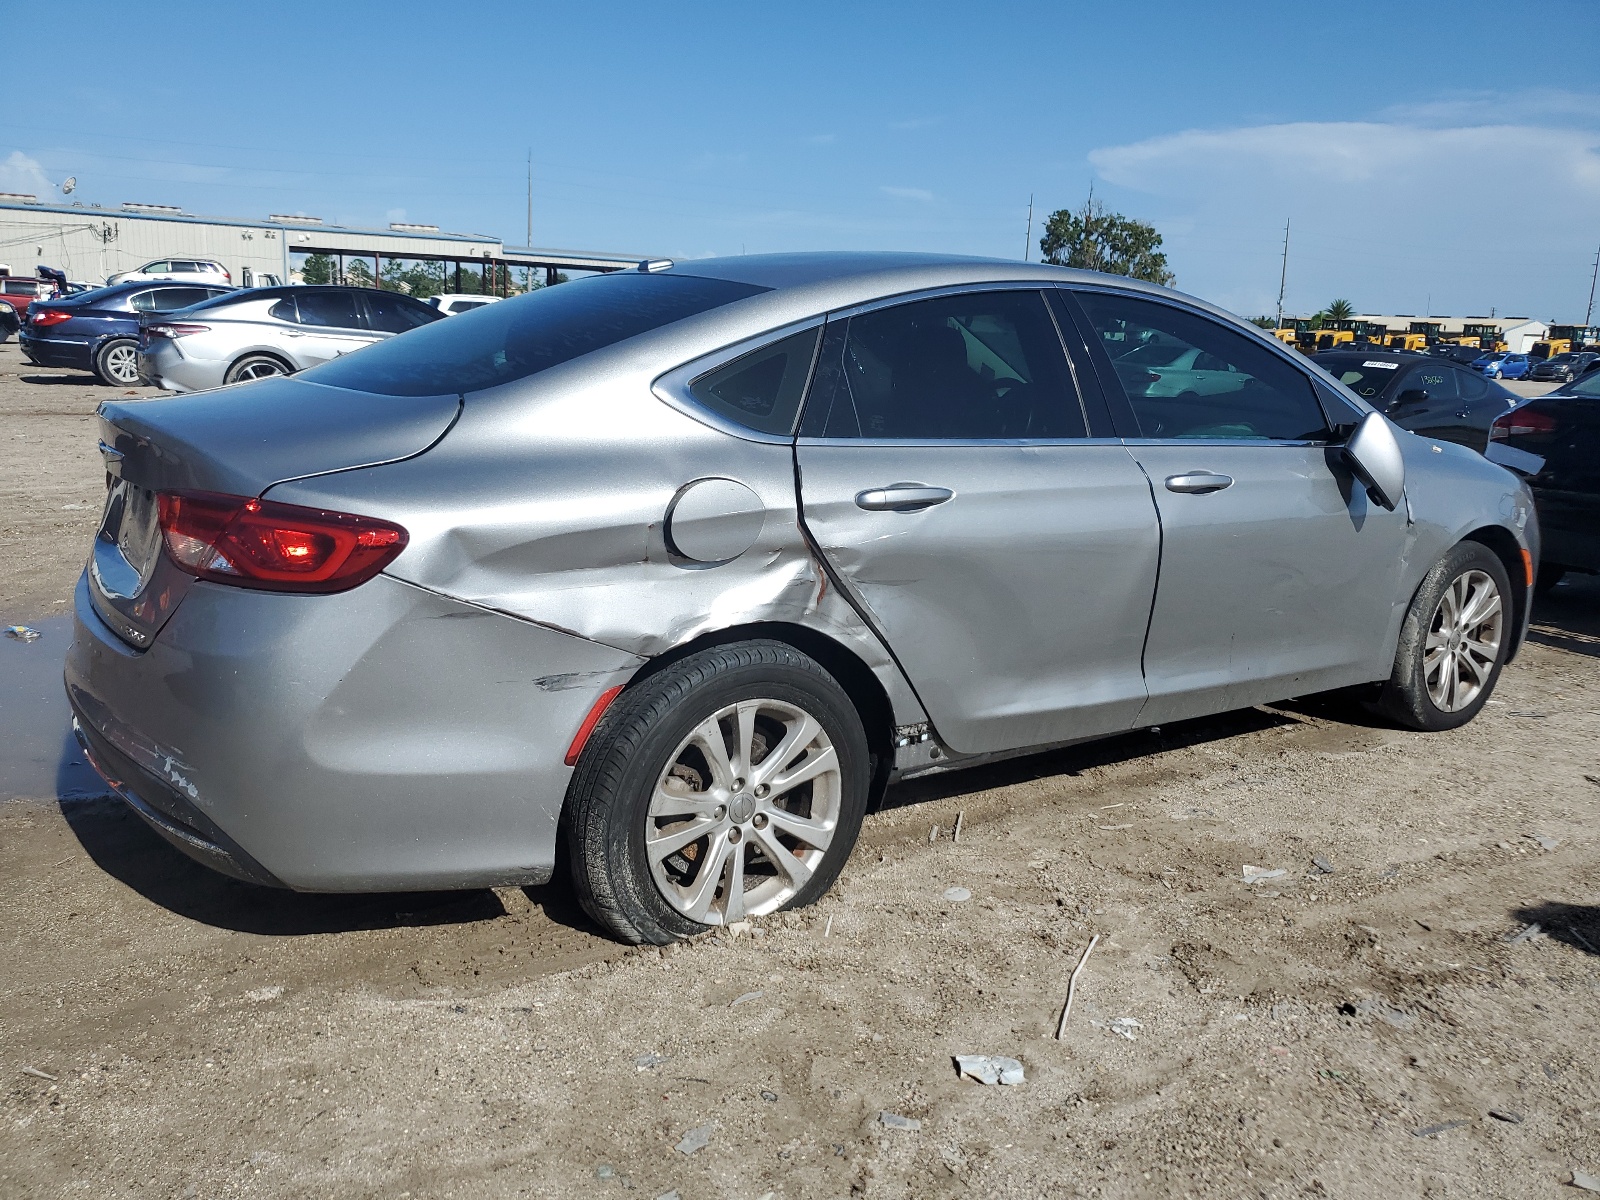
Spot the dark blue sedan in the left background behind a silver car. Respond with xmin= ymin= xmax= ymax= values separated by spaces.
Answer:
xmin=18 ymin=280 xmax=234 ymax=387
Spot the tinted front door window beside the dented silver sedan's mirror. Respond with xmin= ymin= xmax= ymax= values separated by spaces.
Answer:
xmin=1078 ymin=291 xmax=1330 ymax=442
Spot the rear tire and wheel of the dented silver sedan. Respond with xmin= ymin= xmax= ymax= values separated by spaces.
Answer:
xmin=565 ymin=640 xmax=870 ymax=946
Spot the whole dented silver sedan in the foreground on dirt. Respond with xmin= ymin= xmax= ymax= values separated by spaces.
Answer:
xmin=67 ymin=254 xmax=1539 ymax=942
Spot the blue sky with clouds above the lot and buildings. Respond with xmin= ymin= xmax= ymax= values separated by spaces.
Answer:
xmin=0 ymin=0 xmax=1600 ymax=320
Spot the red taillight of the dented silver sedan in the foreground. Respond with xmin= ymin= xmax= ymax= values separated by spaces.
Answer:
xmin=158 ymin=491 xmax=406 ymax=592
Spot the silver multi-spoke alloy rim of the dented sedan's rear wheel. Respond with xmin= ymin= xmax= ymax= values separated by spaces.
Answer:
xmin=645 ymin=699 xmax=843 ymax=925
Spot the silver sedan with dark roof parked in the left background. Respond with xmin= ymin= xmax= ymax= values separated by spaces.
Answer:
xmin=139 ymin=285 xmax=443 ymax=392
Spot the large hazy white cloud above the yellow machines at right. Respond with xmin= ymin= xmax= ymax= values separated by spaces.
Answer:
xmin=1090 ymin=118 xmax=1600 ymax=318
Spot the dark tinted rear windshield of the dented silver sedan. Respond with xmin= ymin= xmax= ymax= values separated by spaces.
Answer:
xmin=302 ymin=270 xmax=766 ymax=395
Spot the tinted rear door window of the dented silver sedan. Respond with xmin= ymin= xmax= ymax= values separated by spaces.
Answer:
xmin=800 ymin=291 xmax=1085 ymax=442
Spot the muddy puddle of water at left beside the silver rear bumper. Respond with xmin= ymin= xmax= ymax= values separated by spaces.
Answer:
xmin=0 ymin=616 xmax=107 ymax=802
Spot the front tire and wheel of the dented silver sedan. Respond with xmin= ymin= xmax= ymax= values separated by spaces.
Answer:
xmin=1378 ymin=541 xmax=1512 ymax=731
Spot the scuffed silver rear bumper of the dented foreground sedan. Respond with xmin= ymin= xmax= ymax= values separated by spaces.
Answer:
xmin=66 ymin=576 xmax=640 ymax=891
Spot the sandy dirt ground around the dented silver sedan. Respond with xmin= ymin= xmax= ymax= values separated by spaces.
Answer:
xmin=0 ymin=344 xmax=1600 ymax=1200
